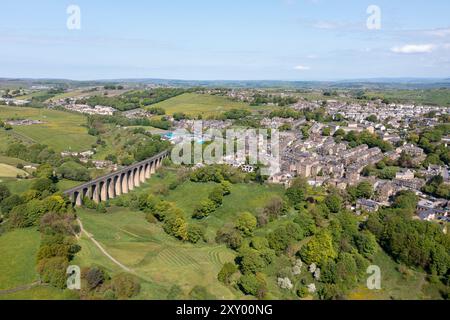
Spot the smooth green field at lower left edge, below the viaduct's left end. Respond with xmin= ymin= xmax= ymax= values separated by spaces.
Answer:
xmin=0 ymin=229 xmax=40 ymax=290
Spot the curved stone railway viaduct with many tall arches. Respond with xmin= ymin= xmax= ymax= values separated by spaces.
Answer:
xmin=64 ymin=151 xmax=169 ymax=207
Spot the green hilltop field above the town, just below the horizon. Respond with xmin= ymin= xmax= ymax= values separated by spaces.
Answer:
xmin=147 ymin=93 xmax=255 ymax=116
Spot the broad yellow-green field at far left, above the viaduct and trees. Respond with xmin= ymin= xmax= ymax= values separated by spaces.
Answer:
xmin=0 ymin=106 xmax=95 ymax=152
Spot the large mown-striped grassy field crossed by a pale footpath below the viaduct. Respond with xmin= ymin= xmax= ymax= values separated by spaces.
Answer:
xmin=74 ymin=208 xmax=239 ymax=299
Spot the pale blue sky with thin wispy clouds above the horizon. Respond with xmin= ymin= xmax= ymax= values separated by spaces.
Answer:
xmin=0 ymin=0 xmax=450 ymax=81
